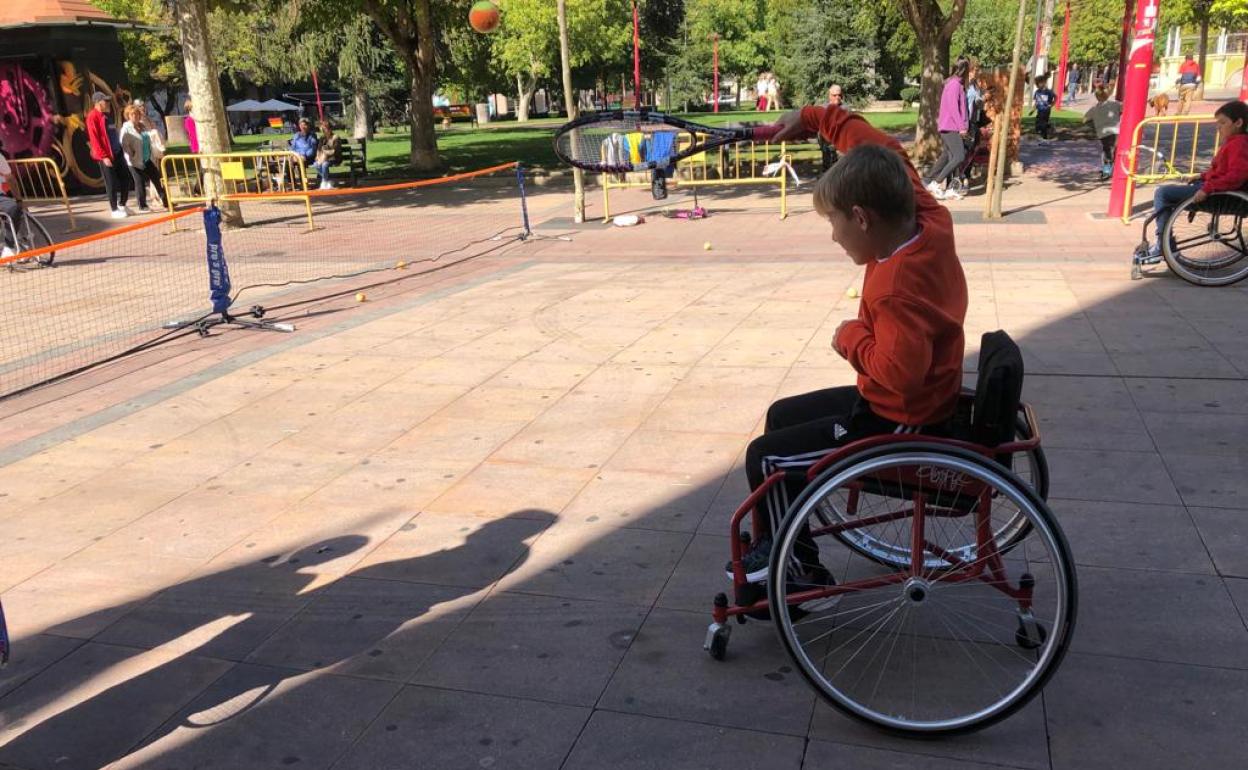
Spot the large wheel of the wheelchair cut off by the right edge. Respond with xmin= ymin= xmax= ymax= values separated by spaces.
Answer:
xmin=1162 ymin=192 xmax=1248 ymax=286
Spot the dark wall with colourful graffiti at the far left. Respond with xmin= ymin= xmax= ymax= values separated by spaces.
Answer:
xmin=0 ymin=27 xmax=130 ymax=190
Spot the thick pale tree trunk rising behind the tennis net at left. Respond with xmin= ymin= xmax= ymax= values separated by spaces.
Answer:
xmin=173 ymin=0 xmax=243 ymax=227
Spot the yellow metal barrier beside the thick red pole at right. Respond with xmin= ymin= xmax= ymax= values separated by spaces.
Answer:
xmin=1122 ymin=115 xmax=1221 ymax=225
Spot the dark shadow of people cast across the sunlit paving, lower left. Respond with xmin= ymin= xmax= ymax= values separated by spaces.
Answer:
xmin=0 ymin=510 xmax=555 ymax=769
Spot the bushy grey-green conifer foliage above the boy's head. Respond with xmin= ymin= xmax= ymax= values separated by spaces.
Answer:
xmin=766 ymin=0 xmax=884 ymax=106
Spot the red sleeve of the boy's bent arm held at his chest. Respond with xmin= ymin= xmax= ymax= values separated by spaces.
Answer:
xmin=835 ymin=295 xmax=936 ymax=398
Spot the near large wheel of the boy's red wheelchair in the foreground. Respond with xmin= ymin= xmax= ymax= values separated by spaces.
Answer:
xmin=768 ymin=442 xmax=1077 ymax=735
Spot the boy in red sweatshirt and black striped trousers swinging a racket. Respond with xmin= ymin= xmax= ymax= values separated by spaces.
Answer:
xmin=728 ymin=100 xmax=967 ymax=585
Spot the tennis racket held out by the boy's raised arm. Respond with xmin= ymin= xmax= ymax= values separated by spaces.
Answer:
xmin=554 ymin=110 xmax=780 ymax=173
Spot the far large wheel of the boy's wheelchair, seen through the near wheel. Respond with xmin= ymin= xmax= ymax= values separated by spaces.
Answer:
xmin=815 ymin=417 xmax=1048 ymax=567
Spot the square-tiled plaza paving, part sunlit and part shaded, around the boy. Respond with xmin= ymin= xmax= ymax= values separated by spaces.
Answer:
xmin=0 ymin=142 xmax=1248 ymax=770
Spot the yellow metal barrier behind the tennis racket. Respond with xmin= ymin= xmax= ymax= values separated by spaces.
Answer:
xmin=600 ymin=135 xmax=790 ymax=221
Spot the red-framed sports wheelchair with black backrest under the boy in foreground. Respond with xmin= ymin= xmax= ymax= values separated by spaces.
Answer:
xmin=704 ymin=332 xmax=1077 ymax=736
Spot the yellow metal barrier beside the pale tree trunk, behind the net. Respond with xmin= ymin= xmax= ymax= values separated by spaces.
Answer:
xmin=160 ymin=150 xmax=312 ymax=230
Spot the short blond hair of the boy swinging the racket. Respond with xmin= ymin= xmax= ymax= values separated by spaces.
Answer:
xmin=815 ymin=145 xmax=915 ymax=222
